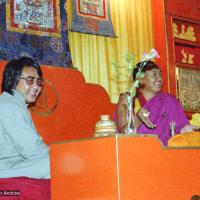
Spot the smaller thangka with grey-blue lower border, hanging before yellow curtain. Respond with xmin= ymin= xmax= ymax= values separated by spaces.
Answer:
xmin=71 ymin=0 xmax=115 ymax=37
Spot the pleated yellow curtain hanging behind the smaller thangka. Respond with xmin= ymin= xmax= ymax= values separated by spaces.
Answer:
xmin=68 ymin=0 xmax=153 ymax=103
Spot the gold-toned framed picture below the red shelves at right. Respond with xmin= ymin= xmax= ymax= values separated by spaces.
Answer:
xmin=176 ymin=67 xmax=200 ymax=112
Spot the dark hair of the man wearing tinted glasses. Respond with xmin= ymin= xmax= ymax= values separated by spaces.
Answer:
xmin=1 ymin=56 xmax=42 ymax=95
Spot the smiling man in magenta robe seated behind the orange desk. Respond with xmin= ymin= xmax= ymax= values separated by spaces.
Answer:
xmin=117 ymin=61 xmax=198 ymax=145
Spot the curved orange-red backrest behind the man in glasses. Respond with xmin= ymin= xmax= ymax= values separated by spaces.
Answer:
xmin=0 ymin=61 xmax=115 ymax=144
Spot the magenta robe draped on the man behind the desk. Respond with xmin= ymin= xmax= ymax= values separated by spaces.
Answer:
xmin=137 ymin=92 xmax=189 ymax=145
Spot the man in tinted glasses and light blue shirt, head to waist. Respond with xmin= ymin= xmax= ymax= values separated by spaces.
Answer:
xmin=0 ymin=57 xmax=50 ymax=179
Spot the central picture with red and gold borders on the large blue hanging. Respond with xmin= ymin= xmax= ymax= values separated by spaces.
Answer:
xmin=6 ymin=0 xmax=61 ymax=37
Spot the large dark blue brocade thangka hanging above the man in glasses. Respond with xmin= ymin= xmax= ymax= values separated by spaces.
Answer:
xmin=0 ymin=0 xmax=71 ymax=67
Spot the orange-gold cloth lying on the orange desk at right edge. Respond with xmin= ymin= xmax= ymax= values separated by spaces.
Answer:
xmin=168 ymin=132 xmax=200 ymax=147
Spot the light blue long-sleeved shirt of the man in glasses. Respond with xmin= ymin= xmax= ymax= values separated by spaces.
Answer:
xmin=0 ymin=90 xmax=50 ymax=179
